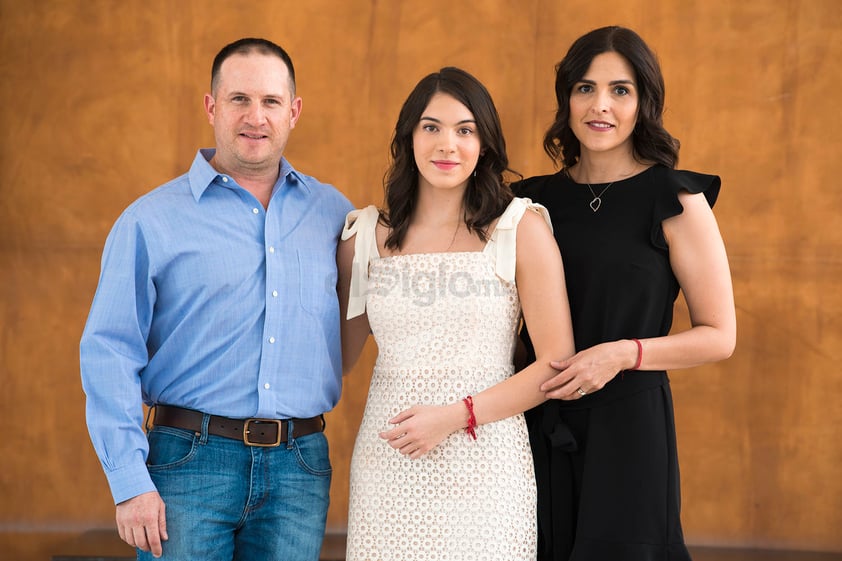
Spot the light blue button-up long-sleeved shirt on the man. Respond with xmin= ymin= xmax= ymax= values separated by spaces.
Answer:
xmin=80 ymin=150 xmax=352 ymax=503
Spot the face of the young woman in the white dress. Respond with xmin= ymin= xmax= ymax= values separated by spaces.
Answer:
xmin=412 ymin=93 xmax=482 ymax=194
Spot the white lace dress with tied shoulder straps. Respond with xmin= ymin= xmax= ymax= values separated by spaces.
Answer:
xmin=343 ymin=199 xmax=549 ymax=561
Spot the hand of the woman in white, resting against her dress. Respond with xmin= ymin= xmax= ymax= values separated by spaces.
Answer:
xmin=379 ymin=402 xmax=468 ymax=460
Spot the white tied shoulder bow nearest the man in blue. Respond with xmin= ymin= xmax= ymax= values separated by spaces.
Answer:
xmin=342 ymin=205 xmax=380 ymax=319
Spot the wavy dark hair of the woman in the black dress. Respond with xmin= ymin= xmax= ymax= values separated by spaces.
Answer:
xmin=544 ymin=26 xmax=680 ymax=168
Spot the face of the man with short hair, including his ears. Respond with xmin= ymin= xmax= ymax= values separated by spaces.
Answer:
xmin=205 ymin=53 xmax=301 ymax=175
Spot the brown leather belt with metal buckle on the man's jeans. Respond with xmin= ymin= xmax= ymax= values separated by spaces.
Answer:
xmin=153 ymin=404 xmax=325 ymax=446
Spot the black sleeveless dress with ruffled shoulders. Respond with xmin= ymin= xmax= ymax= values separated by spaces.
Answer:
xmin=513 ymin=165 xmax=720 ymax=561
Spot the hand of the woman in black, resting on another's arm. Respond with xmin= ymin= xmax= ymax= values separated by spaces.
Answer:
xmin=541 ymin=339 xmax=637 ymax=401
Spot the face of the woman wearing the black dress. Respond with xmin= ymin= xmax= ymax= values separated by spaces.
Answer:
xmin=570 ymin=52 xmax=639 ymax=157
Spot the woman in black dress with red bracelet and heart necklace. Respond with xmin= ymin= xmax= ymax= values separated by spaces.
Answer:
xmin=515 ymin=27 xmax=736 ymax=561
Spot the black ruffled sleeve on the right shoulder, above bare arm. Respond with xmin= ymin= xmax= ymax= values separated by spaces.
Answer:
xmin=651 ymin=166 xmax=722 ymax=249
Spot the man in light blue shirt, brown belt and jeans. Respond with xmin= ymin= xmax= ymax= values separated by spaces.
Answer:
xmin=80 ymin=38 xmax=352 ymax=561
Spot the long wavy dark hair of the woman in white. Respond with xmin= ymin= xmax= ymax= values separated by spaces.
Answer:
xmin=381 ymin=67 xmax=517 ymax=249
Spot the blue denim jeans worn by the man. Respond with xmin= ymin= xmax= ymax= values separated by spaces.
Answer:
xmin=137 ymin=416 xmax=331 ymax=561
